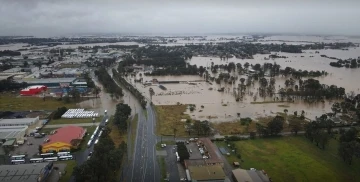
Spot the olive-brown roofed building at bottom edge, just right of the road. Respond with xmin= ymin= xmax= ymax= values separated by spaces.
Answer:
xmin=186 ymin=165 xmax=226 ymax=182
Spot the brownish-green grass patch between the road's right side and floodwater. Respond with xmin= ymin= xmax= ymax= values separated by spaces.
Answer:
xmin=155 ymin=105 xmax=190 ymax=137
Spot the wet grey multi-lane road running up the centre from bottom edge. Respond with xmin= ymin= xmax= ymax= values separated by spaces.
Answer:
xmin=109 ymin=69 xmax=160 ymax=182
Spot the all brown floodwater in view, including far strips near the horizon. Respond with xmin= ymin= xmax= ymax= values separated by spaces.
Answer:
xmin=0 ymin=35 xmax=360 ymax=122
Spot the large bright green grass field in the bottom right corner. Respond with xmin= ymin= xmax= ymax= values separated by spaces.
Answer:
xmin=217 ymin=136 xmax=360 ymax=182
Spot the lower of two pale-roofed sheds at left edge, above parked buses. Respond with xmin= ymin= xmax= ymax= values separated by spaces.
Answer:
xmin=0 ymin=126 xmax=28 ymax=141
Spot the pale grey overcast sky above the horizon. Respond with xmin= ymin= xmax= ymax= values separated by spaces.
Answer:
xmin=0 ymin=0 xmax=360 ymax=36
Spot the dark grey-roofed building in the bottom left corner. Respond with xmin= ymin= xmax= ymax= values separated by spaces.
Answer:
xmin=0 ymin=162 xmax=53 ymax=182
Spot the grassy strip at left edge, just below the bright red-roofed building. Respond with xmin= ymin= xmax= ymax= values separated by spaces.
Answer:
xmin=0 ymin=93 xmax=76 ymax=111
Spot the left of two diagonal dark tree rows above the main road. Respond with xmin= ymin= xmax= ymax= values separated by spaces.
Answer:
xmin=95 ymin=67 xmax=124 ymax=99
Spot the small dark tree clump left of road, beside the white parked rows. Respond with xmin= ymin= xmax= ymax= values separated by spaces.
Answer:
xmin=114 ymin=103 xmax=131 ymax=132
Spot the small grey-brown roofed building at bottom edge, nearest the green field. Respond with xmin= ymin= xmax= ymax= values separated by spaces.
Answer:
xmin=232 ymin=169 xmax=270 ymax=182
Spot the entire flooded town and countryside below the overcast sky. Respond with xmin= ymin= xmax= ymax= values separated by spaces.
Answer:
xmin=0 ymin=35 xmax=360 ymax=182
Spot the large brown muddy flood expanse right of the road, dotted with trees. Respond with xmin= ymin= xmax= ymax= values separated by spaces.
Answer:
xmin=132 ymin=48 xmax=360 ymax=122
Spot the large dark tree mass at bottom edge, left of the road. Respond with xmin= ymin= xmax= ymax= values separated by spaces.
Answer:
xmin=73 ymin=128 xmax=127 ymax=182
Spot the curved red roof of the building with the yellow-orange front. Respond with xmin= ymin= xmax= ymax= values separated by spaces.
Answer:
xmin=44 ymin=125 xmax=86 ymax=145
